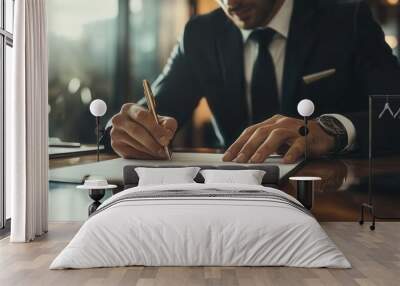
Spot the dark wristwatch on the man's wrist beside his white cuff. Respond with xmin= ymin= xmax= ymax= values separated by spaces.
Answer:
xmin=317 ymin=115 xmax=348 ymax=153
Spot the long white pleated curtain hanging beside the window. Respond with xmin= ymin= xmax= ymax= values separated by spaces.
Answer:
xmin=6 ymin=0 xmax=48 ymax=242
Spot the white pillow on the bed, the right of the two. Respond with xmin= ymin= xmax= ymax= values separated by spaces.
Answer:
xmin=200 ymin=170 xmax=265 ymax=185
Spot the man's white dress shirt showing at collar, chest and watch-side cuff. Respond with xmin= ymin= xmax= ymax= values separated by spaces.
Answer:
xmin=241 ymin=0 xmax=356 ymax=150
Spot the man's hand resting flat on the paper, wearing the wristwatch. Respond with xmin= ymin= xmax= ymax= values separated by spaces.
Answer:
xmin=223 ymin=115 xmax=335 ymax=164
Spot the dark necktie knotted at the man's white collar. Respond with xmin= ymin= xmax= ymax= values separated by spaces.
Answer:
xmin=250 ymin=28 xmax=279 ymax=124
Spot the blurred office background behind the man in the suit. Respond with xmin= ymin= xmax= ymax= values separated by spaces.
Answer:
xmin=47 ymin=0 xmax=400 ymax=150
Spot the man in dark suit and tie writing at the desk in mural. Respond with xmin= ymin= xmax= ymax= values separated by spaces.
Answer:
xmin=109 ymin=0 xmax=400 ymax=163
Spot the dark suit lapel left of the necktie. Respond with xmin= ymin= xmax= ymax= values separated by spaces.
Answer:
xmin=216 ymin=15 xmax=248 ymax=140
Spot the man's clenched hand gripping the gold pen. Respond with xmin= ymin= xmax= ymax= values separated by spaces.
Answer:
xmin=110 ymin=103 xmax=178 ymax=159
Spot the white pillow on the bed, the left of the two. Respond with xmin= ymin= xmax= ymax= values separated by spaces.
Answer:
xmin=135 ymin=167 xmax=200 ymax=186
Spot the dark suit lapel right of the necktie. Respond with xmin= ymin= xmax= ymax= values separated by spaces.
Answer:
xmin=281 ymin=0 xmax=316 ymax=116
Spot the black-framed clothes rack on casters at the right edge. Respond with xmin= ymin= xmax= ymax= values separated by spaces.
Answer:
xmin=360 ymin=95 xmax=400 ymax=230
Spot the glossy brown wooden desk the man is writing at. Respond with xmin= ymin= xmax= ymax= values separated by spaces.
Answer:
xmin=50 ymin=149 xmax=400 ymax=221
